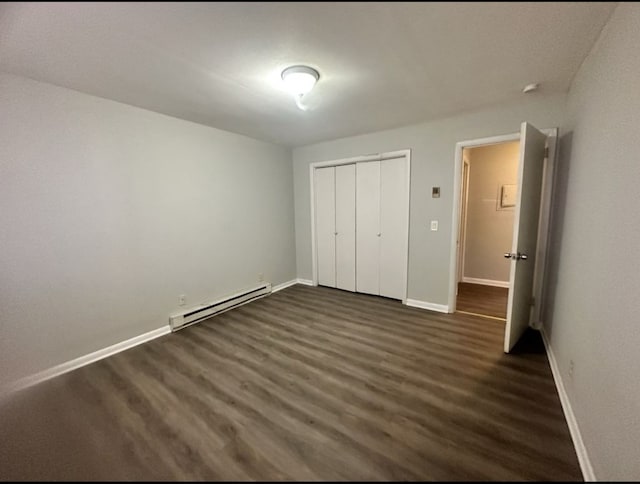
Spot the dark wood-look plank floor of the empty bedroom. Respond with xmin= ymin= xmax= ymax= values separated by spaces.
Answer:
xmin=0 ymin=285 xmax=581 ymax=481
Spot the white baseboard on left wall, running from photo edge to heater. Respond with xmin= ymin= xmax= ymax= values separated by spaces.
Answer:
xmin=2 ymin=325 xmax=171 ymax=394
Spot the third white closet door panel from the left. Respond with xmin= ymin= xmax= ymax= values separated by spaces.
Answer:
xmin=356 ymin=161 xmax=380 ymax=294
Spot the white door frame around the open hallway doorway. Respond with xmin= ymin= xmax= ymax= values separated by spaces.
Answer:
xmin=448 ymin=128 xmax=558 ymax=328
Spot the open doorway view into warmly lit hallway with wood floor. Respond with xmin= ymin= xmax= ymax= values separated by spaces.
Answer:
xmin=456 ymin=140 xmax=520 ymax=321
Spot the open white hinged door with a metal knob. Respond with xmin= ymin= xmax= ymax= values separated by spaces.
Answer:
xmin=504 ymin=123 xmax=547 ymax=353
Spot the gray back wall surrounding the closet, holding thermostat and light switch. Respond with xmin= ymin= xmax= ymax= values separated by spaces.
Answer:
xmin=293 ymin=92 xmax=565 ymax=305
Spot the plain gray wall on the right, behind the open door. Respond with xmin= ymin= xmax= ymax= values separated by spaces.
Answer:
xmin=545 ymin=3 xmax=640 ymax=480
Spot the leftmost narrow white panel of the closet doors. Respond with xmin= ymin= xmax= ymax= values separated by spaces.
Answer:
xmin=314 ymin=167 xmax=336 ymax=287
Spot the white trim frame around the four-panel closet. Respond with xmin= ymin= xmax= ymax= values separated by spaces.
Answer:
xmin=309 ymin=149 xmax=411 ymax=304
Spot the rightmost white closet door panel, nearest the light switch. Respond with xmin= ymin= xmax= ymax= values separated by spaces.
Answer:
xmin=380 ymin=157 xmax=409 ymax=299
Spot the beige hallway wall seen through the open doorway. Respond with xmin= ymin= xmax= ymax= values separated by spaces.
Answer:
xmin=464 ymin=141 xmax=520 ymax=283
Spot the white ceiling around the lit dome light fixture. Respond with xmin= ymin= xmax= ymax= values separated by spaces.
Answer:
xmin=0 ymin=2 xmax=615 ymax=146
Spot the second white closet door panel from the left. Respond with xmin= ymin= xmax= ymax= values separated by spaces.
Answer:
xmin=335 ymin=164 xmax=356 ymax=291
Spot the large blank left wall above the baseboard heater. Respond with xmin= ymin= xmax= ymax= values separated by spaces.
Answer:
xmin=0 ymin=75 xmax=295 ymax=386
